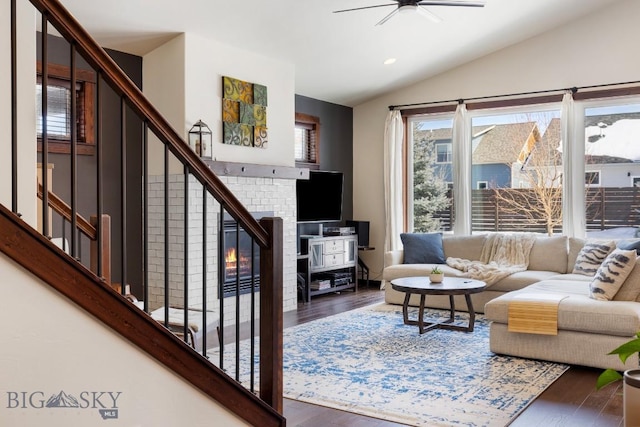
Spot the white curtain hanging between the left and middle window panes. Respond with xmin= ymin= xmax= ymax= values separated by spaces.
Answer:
xmin=452 ymin=103 xmax=471 ymax=235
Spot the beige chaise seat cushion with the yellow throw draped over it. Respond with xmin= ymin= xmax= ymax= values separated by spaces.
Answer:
xmin=484 ymin=280 xmax=640 ymax=336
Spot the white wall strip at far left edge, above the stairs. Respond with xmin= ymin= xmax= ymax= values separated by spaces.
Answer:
xmin=0 ymin=0 xmax=37 ymax=228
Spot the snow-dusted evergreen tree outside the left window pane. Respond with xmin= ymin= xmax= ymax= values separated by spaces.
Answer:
xmin=413 ymin=122 xmax=451 ymax=232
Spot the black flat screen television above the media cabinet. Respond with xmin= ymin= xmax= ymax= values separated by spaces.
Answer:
xmin=296 ymin=171 xmax=344 ymax=222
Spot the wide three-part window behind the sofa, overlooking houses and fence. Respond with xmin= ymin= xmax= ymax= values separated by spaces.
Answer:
xmin=402 ymin=90 xmax=640 ymax=238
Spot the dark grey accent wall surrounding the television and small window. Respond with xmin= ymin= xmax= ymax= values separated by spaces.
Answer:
xmin=295 ymin=95 xmax=353 ymax=234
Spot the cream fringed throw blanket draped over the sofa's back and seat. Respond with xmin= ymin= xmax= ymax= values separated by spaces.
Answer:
xmin=447 ymin=233 xmax=536 ymax=287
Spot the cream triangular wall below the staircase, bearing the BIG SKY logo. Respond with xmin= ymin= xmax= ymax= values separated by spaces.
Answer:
xmin=0 ymin=254 xmax=247 ymax=427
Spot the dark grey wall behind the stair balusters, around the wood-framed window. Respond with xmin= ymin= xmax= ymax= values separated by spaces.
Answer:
xmin=37 ymin=34 xmax=143 ymax=296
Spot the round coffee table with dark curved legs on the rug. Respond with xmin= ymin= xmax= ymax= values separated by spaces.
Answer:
xmin=391 ymin=276 xmax=486 ymax=334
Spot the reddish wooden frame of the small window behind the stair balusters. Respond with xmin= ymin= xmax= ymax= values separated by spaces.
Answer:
xmin=36 ymin=61 xmax=96 ymax=155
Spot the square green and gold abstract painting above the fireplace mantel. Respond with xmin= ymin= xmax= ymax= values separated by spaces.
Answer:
xmin=222 ymin=76 xmax=267 ymax=148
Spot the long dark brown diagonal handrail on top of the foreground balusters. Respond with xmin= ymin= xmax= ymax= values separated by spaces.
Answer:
xmin=30 ymin=0 xmax=270 ymax=248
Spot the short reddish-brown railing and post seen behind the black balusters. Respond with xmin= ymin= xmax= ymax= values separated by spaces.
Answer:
xmin=38 ymin=184 xmax=112 ymax=290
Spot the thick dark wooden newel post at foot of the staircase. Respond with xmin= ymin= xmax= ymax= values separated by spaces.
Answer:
xmin=260 ymin=218 xmax=284 ymax=414
